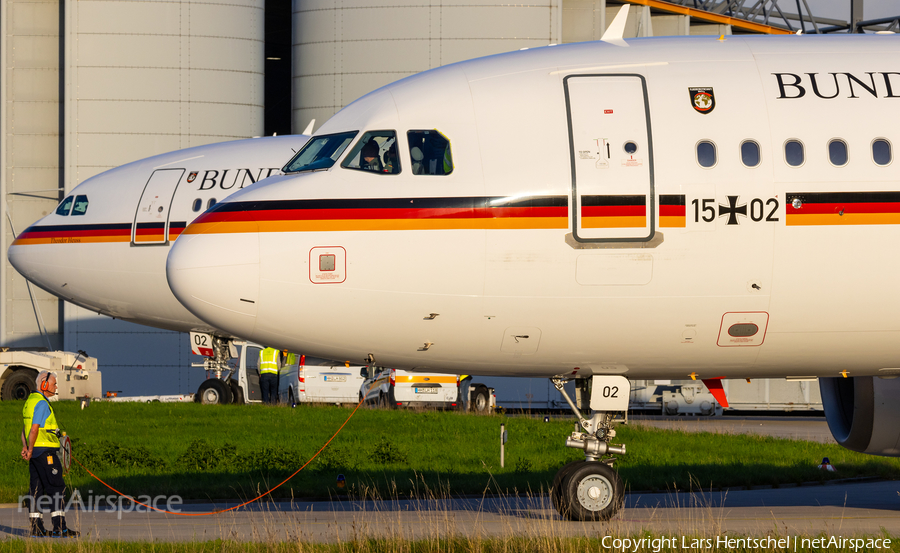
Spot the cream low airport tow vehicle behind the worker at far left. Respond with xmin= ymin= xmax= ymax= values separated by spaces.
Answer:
xmin=0 ymin=348 xmax=102 ymax=400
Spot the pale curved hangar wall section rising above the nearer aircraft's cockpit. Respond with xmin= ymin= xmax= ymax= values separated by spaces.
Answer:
xmin=292 ymin=0 xmax=563 ymax=132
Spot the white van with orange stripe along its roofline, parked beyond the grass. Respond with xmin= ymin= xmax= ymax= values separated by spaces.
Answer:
xmin=359 ymin=367 xmax=459 ymax=409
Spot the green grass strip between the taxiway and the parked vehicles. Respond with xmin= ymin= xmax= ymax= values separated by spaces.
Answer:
xmin=0 ymin=402 xmax=900 ymax=502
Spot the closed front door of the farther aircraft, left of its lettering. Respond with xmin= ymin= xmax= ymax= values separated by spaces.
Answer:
xmin=131 ymin=169 xmax=184 ymax=245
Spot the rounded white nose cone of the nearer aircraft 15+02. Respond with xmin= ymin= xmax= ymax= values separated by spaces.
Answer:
xmin=166 ymin=223 xmax=259 ymax=338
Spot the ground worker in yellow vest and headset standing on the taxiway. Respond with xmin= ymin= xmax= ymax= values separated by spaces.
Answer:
xmin=22 ymin=371 xmax=79 ymax=538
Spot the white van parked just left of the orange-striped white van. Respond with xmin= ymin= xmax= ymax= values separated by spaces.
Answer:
xmin=278 ymin=355 xmax=365 ymax=405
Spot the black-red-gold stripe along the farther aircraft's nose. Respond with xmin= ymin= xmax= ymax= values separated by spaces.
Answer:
xmin=13 ymin=221 xmax=187 ymax=246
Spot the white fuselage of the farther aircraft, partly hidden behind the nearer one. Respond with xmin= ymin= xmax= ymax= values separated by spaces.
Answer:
xmin=9 ymin=135 xmax=308 ymax=331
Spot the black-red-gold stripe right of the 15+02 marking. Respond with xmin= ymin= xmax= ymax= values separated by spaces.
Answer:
xmin=785 ymin=192 xmax=900 ymax=226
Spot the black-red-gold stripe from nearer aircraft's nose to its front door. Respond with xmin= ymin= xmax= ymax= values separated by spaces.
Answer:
xmin=185 ymin=196 xmax=568 ymax=234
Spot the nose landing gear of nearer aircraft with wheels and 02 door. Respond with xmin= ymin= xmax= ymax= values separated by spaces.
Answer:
xmin=550 ymin=376 xmax=630 ymax=521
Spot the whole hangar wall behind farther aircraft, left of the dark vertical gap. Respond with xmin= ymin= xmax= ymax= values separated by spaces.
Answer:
xmin=0 ymin=0 xmax=265 ymax=394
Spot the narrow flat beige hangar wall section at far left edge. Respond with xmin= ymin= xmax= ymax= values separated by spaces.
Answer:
xmin=0 ymin=0 xmax=62 ymax=348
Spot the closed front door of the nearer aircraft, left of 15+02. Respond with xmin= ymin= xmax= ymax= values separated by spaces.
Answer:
xmin=563 ymin=74 xmax=656 ymax=242
